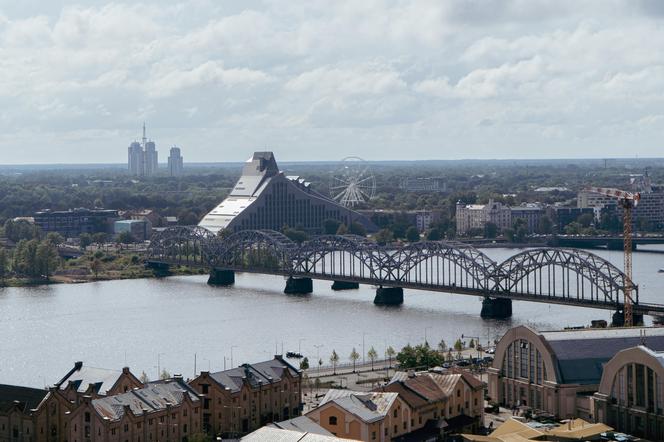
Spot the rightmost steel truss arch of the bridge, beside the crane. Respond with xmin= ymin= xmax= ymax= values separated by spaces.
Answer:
xmin=494 ymin=248 xmax=638 ymax=305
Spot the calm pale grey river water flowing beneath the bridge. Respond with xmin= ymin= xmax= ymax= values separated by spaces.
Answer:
xmin=0 ymin=249 xmax=664 ymax=387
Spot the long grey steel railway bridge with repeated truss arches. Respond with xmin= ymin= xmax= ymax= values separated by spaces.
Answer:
xmin=146 ymin=227 xmax=664 ymax=315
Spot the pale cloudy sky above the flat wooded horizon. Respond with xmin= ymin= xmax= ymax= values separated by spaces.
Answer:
xmin=0 ymin=0 xmax=664 ymax=164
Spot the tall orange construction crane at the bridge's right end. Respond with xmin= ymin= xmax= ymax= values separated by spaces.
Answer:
xmin=586 ymin=187 xmax=641 ymax=327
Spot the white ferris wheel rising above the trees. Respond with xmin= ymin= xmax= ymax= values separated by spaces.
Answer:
xmin=330 ymin=157 xmax=376 ymax=207
